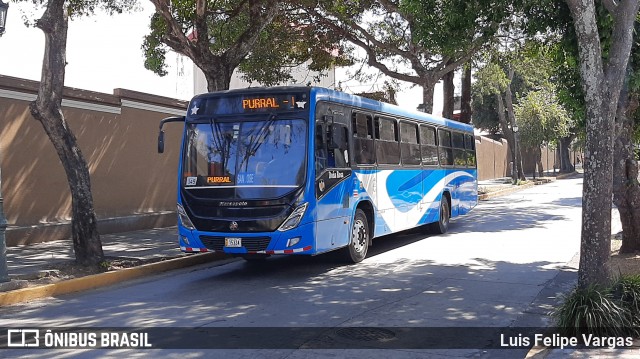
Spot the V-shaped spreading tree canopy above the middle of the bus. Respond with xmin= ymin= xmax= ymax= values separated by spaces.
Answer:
xmin=307 ymin=0 xmax=509 ymax=112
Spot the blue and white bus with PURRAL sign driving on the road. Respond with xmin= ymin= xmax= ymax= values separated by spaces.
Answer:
xmin=158 ymin=87 xmax=478 ymax=263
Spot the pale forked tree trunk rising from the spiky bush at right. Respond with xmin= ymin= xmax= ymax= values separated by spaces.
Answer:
xmin=567 ymin=0 xmax=638 ymax=288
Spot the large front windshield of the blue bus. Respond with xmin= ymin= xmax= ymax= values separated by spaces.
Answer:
xmin=182 ymin=116 xmax=307 ymax=199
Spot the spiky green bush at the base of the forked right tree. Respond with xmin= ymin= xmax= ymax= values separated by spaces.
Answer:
xmin=553 ymin=286 xmax=640 ymax=336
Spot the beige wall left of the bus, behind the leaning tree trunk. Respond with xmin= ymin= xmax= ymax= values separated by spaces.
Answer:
xmin=0 ymin=76 xmax=187 ymax=245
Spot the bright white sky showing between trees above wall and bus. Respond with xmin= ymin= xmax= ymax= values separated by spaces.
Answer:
xmin=0 ymin=0 xmax=442 ymax=113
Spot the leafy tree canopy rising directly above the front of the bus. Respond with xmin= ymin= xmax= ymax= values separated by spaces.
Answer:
xmin=142 ymin=0 xmax=345 ymax=91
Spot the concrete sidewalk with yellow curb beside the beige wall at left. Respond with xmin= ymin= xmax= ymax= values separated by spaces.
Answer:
xmin=0 ymin=227 xmax=230 ymax=307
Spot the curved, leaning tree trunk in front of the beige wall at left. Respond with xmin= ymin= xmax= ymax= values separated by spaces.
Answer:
xmin=29 ymin=0 xmax=104 ymax=265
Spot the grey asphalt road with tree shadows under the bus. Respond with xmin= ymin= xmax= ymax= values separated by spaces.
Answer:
xmin=0 ymin=179 xmax=582 ymax=358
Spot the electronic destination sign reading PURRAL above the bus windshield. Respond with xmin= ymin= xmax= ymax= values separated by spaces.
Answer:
xmin=187 ymin=91 xmax=309 ymax=116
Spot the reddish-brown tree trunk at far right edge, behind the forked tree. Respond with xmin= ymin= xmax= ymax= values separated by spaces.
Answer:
xmin=613 ymin=74 xmax=640 ymax=253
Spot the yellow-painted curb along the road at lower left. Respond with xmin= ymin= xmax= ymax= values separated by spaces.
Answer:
xmin=0 ymin=252 xmax=227 ymax=307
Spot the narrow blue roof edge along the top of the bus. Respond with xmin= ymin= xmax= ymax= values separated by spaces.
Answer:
xmin=194 ymin=86 xmax=473 ymax=132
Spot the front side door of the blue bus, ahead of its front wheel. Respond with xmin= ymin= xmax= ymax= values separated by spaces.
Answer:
xmin=314 ymin=102 xmax=353 ymax=252
